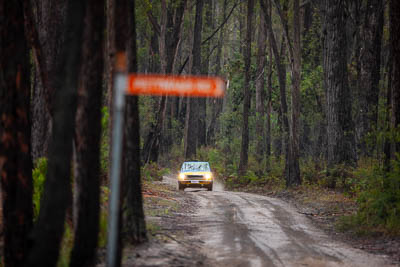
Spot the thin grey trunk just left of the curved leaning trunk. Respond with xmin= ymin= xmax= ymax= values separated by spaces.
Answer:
xmin=255 ymin=10 xmax=266 ymax=165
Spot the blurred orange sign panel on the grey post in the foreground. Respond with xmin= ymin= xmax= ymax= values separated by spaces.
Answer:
xmin=127 ymin=74 xmax=226 ymax=97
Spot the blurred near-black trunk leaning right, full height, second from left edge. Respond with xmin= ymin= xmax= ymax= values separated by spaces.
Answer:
xmin=27 ymin=1 xmax=86 ymax=266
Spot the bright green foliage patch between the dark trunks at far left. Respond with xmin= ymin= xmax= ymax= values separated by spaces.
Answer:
xmin=32 ymin=158 xmax=47 ymax=221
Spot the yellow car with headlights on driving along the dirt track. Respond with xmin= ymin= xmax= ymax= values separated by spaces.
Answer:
xmin=178 ymin=161 xmax=214 ymax=191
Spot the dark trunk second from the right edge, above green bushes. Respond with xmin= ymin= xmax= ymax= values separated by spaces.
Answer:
xmin=359 ymin=0 xmax=384 ymax=156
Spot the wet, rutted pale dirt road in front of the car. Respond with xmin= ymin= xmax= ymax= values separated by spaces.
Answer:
xmin=166 ymin=177 xmax=395 ymax=267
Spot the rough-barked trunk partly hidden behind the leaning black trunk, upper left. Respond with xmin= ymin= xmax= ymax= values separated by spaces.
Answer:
xmin=27 ymin=0 xmax=67 ymax=161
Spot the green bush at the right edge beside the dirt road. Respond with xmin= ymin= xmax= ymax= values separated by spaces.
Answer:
xmin=338 ymin=159 xmax=400 ymax=235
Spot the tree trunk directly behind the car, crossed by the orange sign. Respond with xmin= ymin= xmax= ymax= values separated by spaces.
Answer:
xmin=185 ymin=0 xmax=204 ymax=159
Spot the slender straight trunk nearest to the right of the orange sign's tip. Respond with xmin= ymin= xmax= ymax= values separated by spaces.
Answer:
xmin=239 ymin=0 xmax=254 ymax=175
